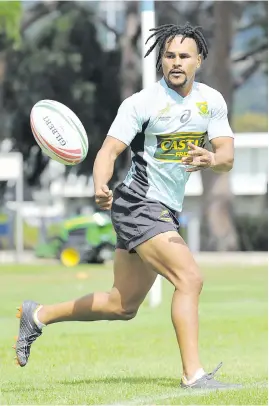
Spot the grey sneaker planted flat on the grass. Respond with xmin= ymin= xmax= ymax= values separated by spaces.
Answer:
xmin=180 ymin=362 xmax=242 ymax=390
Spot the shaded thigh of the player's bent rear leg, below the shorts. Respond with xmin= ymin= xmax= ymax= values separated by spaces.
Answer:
xmin=112 ymin=249 xmax=157 ymax=310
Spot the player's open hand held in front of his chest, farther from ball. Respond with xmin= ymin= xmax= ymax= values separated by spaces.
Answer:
xmin=182 ymin=142 xmax=215 ymax=172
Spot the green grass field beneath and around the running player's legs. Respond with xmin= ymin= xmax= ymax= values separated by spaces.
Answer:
xmin=0 ymin=264 xmax=268 ymax=405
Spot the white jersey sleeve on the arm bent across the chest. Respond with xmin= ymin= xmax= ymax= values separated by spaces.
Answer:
xmin=207 ymin=92 xmax=234 ymax=141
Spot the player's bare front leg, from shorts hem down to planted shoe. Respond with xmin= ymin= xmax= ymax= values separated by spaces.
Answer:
xmin=136 ymin=231 xmax=202 ymax=378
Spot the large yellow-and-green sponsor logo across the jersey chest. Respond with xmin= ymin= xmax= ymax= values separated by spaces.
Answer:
xmin=154 ymin=132 xmax=207 ymax=162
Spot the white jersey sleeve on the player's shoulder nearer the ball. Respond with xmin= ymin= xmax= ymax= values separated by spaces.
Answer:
xmin=108 ymin=94 xmax=143 ymax=145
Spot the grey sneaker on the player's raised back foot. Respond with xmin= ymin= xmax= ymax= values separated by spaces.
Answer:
xmin=14 ymin=300 xmax=42 ymax=367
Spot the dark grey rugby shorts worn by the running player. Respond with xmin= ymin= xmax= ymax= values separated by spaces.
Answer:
xmin=111 ymin=184 xmax=179 ymax=252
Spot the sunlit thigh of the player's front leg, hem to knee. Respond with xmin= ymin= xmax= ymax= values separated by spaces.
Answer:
xmin=135 ymin=231 xmax=201 ymax=286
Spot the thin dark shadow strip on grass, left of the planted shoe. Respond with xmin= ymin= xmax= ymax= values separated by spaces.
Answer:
xmin=57 ymin=376 xmax=180 ymax=388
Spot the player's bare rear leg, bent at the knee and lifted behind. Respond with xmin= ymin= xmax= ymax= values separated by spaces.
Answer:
xmin=38 ymin=249 xmax=156 ymax=324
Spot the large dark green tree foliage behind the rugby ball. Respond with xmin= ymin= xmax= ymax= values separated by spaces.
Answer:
xmin=4 ymin=3 xmax=120 ymax=183
